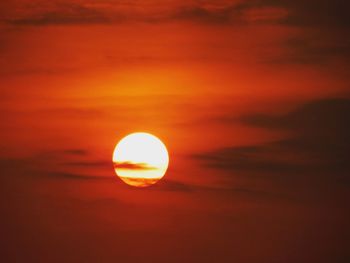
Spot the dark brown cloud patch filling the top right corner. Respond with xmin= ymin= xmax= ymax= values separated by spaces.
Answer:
xmin=249 ymin=0 xmax=350 ymax=64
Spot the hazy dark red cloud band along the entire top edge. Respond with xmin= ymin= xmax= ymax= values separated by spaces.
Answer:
xmin=3 ymin=0 xmax=350 ymax=27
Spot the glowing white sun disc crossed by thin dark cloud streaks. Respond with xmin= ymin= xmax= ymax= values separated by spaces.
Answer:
xmin=113 ymin=132 xmax=169 ymax=187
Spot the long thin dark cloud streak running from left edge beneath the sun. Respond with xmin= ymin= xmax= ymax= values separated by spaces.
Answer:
xmin=0 ymin=153 xmax=286 ymax=196
